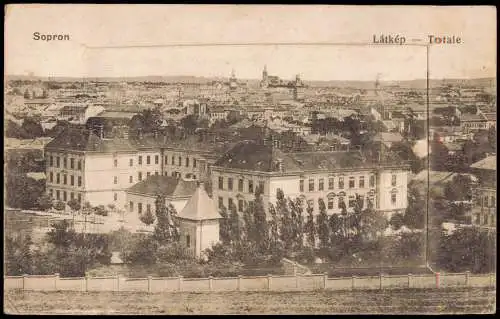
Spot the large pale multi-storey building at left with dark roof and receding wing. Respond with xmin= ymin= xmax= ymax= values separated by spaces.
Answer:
xmin=45 ymin=129 xmax=229 ymax=208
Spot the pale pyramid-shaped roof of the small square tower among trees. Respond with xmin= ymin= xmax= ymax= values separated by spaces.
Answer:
xmin=177 ymin=184 xmax=222 ymax=221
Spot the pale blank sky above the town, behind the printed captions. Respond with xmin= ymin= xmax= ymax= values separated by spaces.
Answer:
xmin=4 ymin=4 xmax=496 ymax=80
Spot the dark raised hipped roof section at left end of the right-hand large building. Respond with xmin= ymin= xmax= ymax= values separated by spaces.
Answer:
xmin=215 ymin=141 xmax=300 ymax=172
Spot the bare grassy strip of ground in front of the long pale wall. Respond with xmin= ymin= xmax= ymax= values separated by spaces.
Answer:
xmin=4 ymin=288 xmax=496 ymax=314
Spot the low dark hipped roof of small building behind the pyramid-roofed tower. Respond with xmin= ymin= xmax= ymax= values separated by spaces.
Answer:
xmin=127 ymin=175 xmax=196 ymax=198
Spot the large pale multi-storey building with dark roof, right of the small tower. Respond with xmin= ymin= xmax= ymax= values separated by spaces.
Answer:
xmin=212 ymin=141 xmax=409 ymax=216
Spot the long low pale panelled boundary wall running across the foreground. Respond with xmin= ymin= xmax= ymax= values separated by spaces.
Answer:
xmin=4 ymin=272 xmax=496 ymax=293
